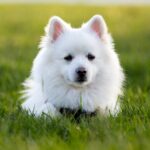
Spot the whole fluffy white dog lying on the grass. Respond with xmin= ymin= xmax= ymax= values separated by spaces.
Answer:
xmin=22 ymin=15 xmax=124 ymax=116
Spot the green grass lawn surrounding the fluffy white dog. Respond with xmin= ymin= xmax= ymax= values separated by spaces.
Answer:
xmin=0 ymin=5 xmax=150 ymax=150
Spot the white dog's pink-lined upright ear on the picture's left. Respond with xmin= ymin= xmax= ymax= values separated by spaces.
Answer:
xmin=45 ymin=16 xmax=69 ymax=42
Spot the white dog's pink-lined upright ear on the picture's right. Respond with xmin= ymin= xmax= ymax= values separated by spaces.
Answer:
xmin=83 ymin=15 xmax=108 ymax=39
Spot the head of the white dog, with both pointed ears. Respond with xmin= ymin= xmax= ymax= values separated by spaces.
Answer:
xmin=41 ymin=15 xmax=111 ymax=87
